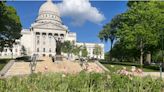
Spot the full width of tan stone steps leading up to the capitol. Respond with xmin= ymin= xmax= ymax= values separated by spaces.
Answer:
xmin=5 ymin=57 xmax=103 ymax=76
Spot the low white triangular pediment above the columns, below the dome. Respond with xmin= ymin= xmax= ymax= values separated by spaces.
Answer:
xmin=33 ymin=23 xmax=66 ymax=30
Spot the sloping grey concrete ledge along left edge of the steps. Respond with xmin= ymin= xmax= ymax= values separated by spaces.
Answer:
xmin=0 ymin=60 xmax=15 ymax=76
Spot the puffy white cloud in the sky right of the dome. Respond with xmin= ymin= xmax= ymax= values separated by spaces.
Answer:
xmin=58 ymin=0 xmax=105 ymax=25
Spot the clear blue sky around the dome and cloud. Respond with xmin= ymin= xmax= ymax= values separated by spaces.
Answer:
xmin=7 ymin=1 xmax=127 ymax=51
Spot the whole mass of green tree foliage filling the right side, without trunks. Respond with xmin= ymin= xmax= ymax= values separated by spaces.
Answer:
xmin=100 ymin=1 xmax=164 ymax=61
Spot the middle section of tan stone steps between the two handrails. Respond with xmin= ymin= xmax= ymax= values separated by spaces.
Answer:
xmin=36 ymin=58 xmax=82 ymax=73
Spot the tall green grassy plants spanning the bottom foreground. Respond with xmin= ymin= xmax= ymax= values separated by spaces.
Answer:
xmin=0 ymin=72 xmax=164 ymax=92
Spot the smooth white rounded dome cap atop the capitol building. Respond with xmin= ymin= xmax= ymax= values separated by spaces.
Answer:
xmin=39 ymin=0 xmax=60 ymax=16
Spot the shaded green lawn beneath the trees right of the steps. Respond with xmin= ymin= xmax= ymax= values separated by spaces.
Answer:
xmin=101 ymin=62 xmax=159 ymax=72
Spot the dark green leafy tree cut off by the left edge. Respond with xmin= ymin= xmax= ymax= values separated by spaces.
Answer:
xmin=0 ymin=1 xmax=22 ymax=52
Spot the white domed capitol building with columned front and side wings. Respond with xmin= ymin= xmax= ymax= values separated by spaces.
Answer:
xmin=0 ymin=0 xmax=104 ymax=59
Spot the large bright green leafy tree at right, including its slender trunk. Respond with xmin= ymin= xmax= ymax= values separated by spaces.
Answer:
xmin=100 ymin=1 xmax=164 ymax=66
